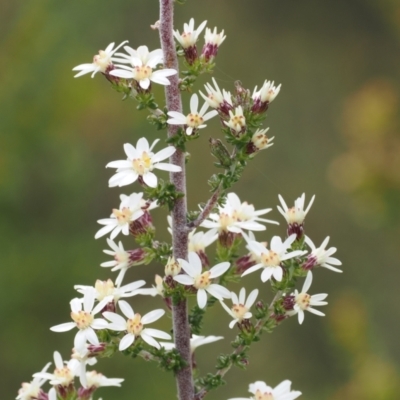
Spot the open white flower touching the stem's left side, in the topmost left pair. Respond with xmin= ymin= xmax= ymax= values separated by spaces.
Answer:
xmin=110 ymin=46 xmax=177 ymax=90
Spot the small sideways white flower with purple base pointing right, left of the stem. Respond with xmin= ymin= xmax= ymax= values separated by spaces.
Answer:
xmin=100 ymin=238 xmax=145 ymax=287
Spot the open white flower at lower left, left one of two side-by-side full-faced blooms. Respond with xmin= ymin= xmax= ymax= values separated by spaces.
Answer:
xmin=50 ymin=291 xmax=108 ymax=351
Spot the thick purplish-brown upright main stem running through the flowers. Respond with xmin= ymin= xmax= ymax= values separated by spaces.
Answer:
xmin=159 ymin=0 xmax=194 ymax=400
